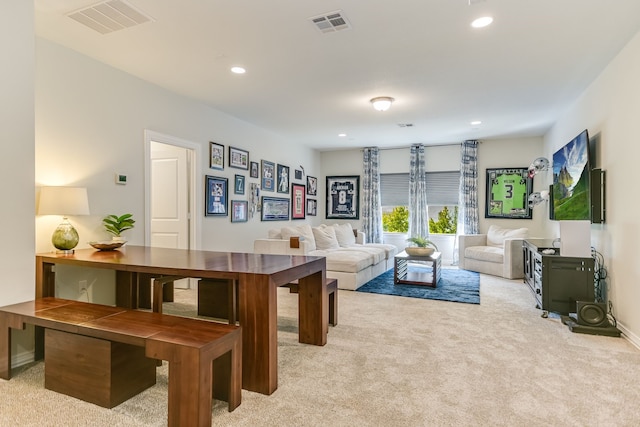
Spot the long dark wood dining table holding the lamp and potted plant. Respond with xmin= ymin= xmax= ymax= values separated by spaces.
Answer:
xmin=36 ymin=245 xmax=328 ymax=395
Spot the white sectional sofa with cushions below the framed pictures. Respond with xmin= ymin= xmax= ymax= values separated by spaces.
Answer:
xmin=253 ymin=223 xmax=398 ymax=290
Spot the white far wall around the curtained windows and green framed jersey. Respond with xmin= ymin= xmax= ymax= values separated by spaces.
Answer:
xmin=318 ymin=138 xmax=547 ymax=236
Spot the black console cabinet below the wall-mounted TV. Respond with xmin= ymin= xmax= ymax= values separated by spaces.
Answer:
xmin=522 ymin=239 xmax=595 ymax=314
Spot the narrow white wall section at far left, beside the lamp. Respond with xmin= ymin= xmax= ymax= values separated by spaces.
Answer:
xmin=0 ymin=0 xmax=35 ymax=361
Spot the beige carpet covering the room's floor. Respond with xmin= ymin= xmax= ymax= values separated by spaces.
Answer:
xmin=0 ymin=275 xmax=640 ymax=427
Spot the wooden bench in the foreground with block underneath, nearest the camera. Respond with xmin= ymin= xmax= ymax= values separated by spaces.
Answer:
xmin=0 ymin=297 xmax=242 ymax=426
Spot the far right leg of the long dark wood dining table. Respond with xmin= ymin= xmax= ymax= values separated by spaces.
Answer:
xmin=298 ymin=270 xmax=329 ymax=345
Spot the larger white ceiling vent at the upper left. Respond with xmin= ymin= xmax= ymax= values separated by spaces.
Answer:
xmin=67 ymin=0 xmax=153 ymax=34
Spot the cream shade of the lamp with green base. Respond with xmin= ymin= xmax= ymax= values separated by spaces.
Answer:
xmin=38 ymin=187 xmax=89 ymax=216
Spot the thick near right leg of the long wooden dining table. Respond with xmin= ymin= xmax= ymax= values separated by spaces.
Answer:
xmin=238 ymin=273 xmax=278 ymax=394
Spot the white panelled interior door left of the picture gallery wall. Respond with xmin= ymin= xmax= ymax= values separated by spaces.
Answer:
xmin=149 ymin=141 xmax=191 ymax=288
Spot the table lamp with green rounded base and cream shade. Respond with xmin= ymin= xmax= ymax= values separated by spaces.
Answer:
xmin=38 ymin=187 xmax=89 ymax=253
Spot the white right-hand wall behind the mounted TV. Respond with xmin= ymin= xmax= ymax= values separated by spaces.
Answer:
xmin=544 ymin=29 xmax=640 ymax=346
